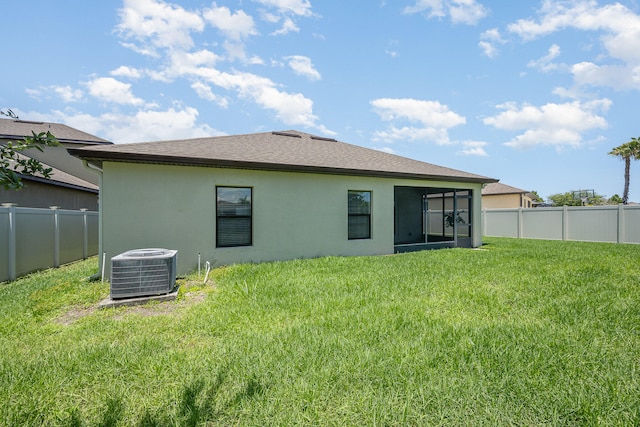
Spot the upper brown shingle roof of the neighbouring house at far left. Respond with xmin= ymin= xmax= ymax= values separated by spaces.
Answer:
xmin=0 ymin=119 xmax=113 ymax=145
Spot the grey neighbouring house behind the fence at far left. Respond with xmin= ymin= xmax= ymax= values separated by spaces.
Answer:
xmin=0 ymin=119 xmax=112 ymax=210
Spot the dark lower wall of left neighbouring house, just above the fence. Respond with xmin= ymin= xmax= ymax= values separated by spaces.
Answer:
xmin=0 ymin=179 xmax=98 ymax=211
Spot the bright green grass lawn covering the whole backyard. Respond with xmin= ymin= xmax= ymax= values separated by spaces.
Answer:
xmin=0 ymin=238 xmax=640 ymax=426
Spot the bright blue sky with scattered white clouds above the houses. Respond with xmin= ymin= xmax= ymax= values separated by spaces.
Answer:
xmin=0 ymin=0 xmax=640 ymax=202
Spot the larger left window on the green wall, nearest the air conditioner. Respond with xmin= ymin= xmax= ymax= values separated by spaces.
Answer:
xmin=216 ymin=187 xmax=251 ymax=248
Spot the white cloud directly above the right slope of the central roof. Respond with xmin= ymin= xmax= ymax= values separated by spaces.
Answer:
xmin=371 ymin=98 xmax=466 ymax=144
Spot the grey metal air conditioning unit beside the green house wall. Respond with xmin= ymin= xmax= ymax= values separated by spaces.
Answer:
xmin=111 ymin=248 xmax=178 ymax=299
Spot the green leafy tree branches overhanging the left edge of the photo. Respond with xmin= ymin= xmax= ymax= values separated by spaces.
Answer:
xmin=0 ymin=110 xmax=59 ymax=190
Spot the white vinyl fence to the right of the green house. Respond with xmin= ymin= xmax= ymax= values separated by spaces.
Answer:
xmin=482 ymin=205 xmax=640 ymax=243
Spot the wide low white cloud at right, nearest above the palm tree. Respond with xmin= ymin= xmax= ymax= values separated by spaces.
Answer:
xmin=483 ymin=98 xmax=611 ymax=149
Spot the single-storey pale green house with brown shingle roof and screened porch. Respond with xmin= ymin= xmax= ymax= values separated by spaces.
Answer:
xmin=69 ymin=131 xmax=496 ymax=275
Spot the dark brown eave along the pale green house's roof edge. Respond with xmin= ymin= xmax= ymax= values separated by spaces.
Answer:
xmin=67 ymin=148 xmax=498 ymax=184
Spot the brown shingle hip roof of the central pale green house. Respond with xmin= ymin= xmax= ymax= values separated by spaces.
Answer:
xmin=68 ymin=130 xmax=497 ymax=183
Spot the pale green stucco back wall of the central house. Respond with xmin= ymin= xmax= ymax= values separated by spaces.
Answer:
xmin=101 ymin=162 xmax=482 ymax=274
